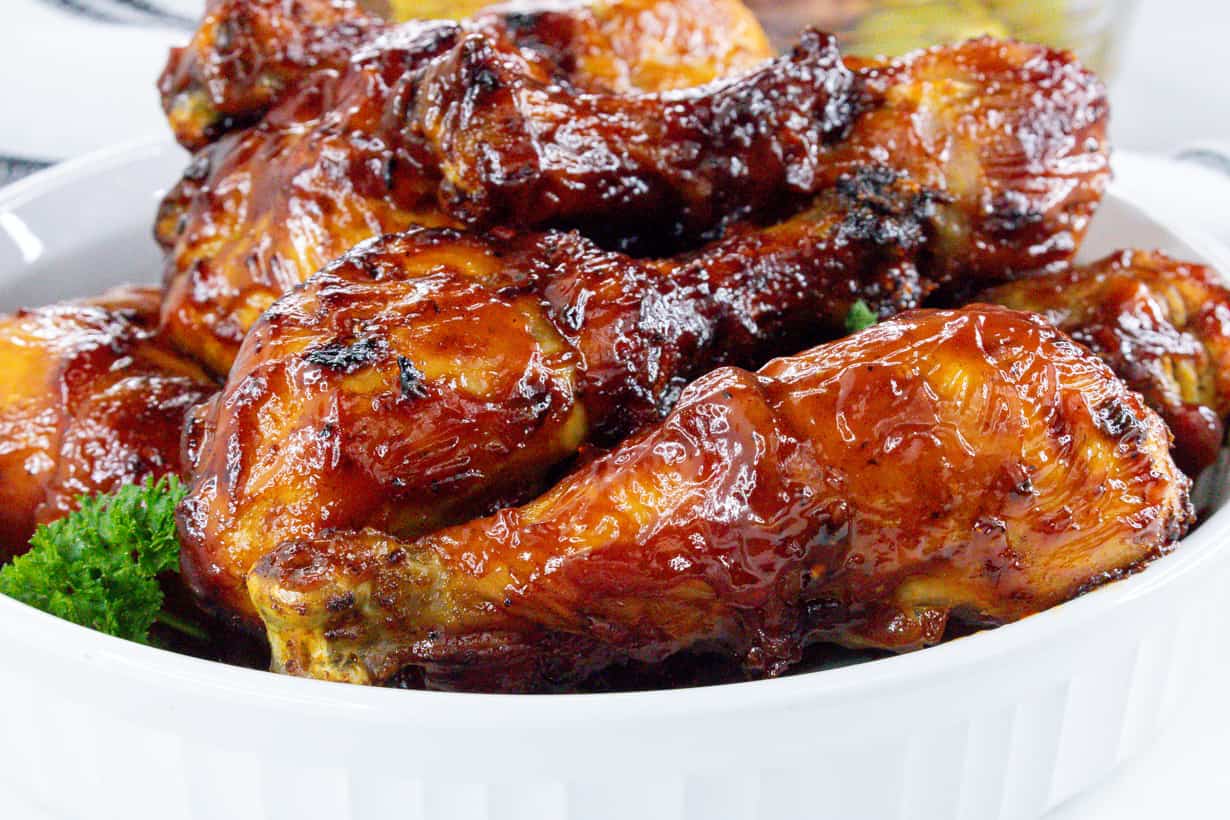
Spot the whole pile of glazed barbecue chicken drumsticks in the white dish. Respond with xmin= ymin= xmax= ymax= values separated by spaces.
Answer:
xmin=0 ymin=0 xmax=1230 ymax=691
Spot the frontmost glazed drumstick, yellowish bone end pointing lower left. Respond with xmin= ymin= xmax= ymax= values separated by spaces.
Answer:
xmin=248 ymin=305 xmax=1192 ymax=691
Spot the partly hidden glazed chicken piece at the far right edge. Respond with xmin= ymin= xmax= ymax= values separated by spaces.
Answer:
xmin=979 ymin=251 xmax=1230 ymax=476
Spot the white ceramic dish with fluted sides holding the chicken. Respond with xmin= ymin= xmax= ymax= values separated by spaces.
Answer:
xmin=0 ymin=141 xmax=1230 ymax=820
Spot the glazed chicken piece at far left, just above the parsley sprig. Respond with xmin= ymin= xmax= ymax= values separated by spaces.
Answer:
xmin=0 ymin=289 xmax=218 ymax=561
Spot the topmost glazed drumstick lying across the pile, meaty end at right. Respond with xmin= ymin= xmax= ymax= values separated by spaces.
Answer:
xmin=428 ymin=32 xmax=1107 ymax=264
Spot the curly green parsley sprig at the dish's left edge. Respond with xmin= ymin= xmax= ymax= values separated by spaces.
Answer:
xmin=0 ymin=476 xmax=186 ymax=643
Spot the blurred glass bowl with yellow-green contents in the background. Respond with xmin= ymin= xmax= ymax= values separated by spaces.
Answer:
xmin=747 ymin=0 xmax=1137 ymax=77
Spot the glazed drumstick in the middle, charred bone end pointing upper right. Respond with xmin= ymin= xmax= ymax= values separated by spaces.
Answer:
xmin=180 ymin=167 xmax=956 ymax=622
